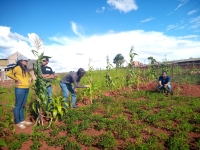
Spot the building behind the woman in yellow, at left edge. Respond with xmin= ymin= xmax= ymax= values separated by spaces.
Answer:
xmin=0 ymin=52 xmax=36 ymax=82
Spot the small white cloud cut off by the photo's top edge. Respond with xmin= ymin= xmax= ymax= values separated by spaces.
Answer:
xmin=107 ymin=0 xmax=138 ymax=13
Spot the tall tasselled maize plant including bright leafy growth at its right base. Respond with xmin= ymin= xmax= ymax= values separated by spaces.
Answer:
xmin=31 ymin=36 xmax=67 ymax=126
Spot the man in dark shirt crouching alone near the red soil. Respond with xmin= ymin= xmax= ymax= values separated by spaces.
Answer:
xmin=158 ymin=71 xmax=172 ymax=95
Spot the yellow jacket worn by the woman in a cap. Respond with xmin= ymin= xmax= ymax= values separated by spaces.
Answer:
xmin=6 ymin=66 xmax=30 ymax=88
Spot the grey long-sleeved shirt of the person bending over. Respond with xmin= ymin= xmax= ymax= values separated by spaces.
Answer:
xmin=61 ymin=72 xmax=85 ymax=88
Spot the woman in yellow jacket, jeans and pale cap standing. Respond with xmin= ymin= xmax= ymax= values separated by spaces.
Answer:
xmin=6 ymin=55 xmax=32 ymax=129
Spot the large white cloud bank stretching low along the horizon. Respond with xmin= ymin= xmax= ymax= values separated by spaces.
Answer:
xmin=0 ymin=27 xmax=200 ymax=72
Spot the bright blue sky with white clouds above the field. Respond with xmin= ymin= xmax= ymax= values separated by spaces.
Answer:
xmin=0 ymin=0 xmax=200 ymax=72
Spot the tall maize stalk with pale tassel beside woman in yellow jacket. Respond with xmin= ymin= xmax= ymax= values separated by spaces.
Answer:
xmin=31 ymin=36 xmax=61 ymax=125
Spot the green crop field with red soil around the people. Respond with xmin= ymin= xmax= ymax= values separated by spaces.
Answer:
xmin=0 ymin=46 xmax=200 ymax=150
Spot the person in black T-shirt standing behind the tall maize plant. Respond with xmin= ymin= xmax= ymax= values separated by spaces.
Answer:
xmin=41 ymin=57 xmax=57 ymax=108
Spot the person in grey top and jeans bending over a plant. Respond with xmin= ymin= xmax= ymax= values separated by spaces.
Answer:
xmin=60 ymin=68 xmax=89 ymax=108
